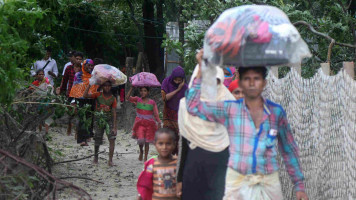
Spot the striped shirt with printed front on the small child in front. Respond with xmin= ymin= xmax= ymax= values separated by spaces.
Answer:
xmin=147 ymin=159 xmax=177 ymax=200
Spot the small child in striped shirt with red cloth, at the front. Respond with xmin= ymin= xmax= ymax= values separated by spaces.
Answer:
xmin=137 ymin=128 xmax=180 ymax=200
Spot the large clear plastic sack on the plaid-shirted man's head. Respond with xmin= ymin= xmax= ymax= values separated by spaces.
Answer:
xmin=204 ymin=5 xmax=311 ymax=67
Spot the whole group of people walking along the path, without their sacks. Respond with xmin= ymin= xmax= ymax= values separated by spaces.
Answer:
xmin=32 ymin=46 xmax=308 ymax=200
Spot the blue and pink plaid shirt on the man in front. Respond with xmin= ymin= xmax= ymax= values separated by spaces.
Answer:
xmin=186 ymin=79 xmax=304 ymax=191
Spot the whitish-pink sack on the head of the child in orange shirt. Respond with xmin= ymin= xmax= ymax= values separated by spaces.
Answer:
xmin=89 ymin=64 xmax=127 ymax=87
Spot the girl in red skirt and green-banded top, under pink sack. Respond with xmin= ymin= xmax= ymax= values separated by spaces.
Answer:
xmin=126 ymin=87 xmax=161 ymax=161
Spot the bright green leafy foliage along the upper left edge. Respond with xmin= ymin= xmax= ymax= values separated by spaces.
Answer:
xmin=0 ymin=0 xmax=43 ymax=104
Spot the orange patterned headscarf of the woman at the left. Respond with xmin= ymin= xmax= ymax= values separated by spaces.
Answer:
xmin=69 ymin=59 xmax=99 ymax=98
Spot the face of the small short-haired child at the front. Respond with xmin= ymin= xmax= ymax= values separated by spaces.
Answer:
xmin=155 ymin=133 xmax=175 ymax=158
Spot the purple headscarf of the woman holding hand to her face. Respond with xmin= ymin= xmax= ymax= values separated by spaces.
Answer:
xmin=162 ymin=66 xmax=188 ymax=111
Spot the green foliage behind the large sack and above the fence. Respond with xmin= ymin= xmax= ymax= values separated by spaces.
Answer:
xmin=164 ymin=0 xmax=356 ymax=77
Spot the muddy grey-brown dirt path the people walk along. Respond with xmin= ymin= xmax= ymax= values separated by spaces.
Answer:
xmin=49 ymin=127 xmax=156 ymax=200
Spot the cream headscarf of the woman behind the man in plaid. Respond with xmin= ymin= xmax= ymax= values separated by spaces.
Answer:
xmin=178 ymin=66 xmax=235 ymax=152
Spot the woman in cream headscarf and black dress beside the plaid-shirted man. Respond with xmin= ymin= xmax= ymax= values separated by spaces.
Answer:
xmin=177 ymin=65 xmax=235 ymax=200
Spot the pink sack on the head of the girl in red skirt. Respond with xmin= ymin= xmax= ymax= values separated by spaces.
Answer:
xmin=130 ymin=72 xmax=161 ymax=87
